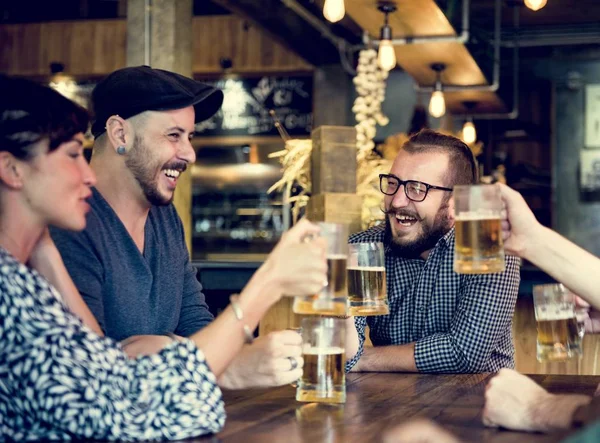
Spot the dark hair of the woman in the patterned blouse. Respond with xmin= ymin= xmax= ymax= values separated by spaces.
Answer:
xmin=0 ymin=75 xmax=89 ymax=160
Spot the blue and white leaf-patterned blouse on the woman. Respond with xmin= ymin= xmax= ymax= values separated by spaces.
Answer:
xmin=0 ymin=248 xmax=225 ymax=441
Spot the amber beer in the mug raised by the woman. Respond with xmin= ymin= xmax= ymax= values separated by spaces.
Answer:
xmin=293 ymin=255 xmax=348 ymax=315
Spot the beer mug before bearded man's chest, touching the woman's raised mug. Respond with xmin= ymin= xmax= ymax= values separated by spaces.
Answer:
xmin=348 ymin=243 xmax=390 ymax=316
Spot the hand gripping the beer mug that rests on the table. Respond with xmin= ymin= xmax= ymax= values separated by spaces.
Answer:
xmin=219 ymin=330 xmax=304 ymax=389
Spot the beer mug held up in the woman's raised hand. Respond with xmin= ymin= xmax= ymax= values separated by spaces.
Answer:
xmin=292 ymin=222 xmax=348 ymax=315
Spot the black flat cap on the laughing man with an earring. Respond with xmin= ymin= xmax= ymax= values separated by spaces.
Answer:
xmin=92 ymin=66 xmax=223 ymax=137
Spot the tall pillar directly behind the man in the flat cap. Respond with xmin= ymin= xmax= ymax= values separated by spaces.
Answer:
xmin=127 ymin=0 xmax=193 ymax=253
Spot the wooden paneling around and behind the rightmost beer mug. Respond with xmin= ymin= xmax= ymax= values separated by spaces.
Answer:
xmin=513 ymin=296 xmax=600 ymax=375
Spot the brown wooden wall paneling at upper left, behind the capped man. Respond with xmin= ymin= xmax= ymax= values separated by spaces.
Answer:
xmin=0 ymin=15 xmax=313 ymax=77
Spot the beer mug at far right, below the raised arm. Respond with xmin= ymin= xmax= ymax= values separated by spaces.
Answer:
xmin=533 ymin=284 xmax=582 ymax=362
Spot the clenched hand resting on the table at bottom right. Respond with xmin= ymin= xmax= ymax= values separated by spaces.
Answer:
xmin=483 ymin=369 xmax=591 ymax=431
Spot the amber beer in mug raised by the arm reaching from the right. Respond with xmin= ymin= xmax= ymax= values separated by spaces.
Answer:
xmin=454 ymin=213 xmax=505 ymax=274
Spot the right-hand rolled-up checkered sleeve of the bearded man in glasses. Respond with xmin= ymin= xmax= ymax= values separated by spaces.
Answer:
xmin=415 ymin=256 xmax=520 ymax=373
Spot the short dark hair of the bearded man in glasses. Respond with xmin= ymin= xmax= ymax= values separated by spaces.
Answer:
xmin=402 ymin=129 xmax=479 ymax=186
